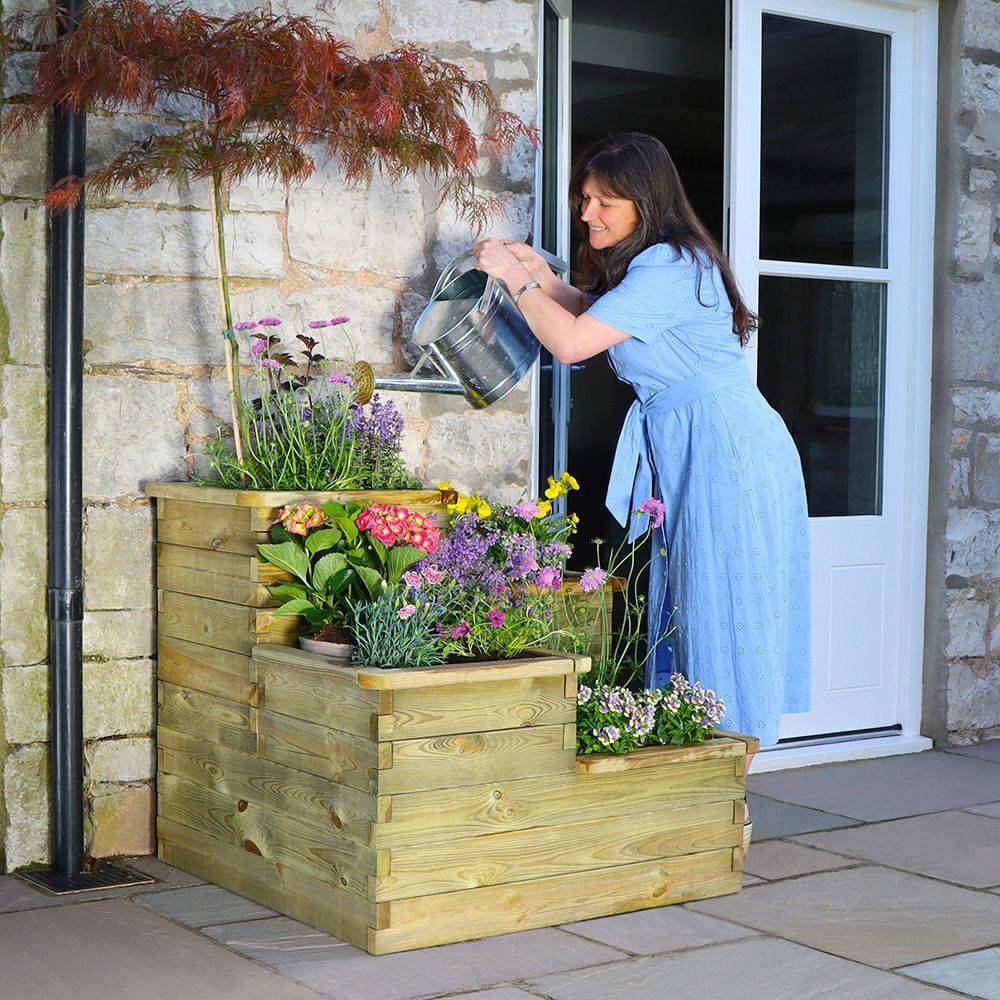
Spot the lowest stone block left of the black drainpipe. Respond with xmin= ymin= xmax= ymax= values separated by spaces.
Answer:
xmin=3 ymin=743 xmax=49 ymax=870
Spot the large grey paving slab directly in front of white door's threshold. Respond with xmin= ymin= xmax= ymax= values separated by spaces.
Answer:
xmin=747 ymin=750 xmax=1000 ymax=820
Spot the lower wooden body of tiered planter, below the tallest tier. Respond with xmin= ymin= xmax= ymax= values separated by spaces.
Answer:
xmin=157 ymin=646 xmax=752 ymax=954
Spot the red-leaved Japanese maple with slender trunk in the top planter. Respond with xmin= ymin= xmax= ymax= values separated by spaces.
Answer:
xmin=0 ymin=0 xmax=537 ymax=460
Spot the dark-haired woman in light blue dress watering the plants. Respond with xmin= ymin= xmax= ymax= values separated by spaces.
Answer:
xmin=476 ymin=132 xmax=810 ymax=745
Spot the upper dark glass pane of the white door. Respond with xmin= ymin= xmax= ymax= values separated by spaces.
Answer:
xmin=760 ymin=14 xmax=889 ymax=267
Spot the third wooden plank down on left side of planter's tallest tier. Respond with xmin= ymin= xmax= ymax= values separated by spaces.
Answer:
xmin=157 ymin=590 xmax=299 ymax=656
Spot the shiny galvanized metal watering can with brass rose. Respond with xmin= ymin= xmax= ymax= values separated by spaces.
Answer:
xmin=354 ymin=250 xmax=567 ymax=409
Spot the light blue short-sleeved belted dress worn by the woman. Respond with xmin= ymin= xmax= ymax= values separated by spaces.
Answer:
xmin=589 ymin=244 xmax=810 ymax=746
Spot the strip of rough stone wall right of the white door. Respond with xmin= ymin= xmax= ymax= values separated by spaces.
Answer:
xmin=930 ymin=0 xmax=1000 ymax=743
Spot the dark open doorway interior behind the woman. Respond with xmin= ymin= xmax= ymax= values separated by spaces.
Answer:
xmin=556 ymin=0 xmax=727 ymax=568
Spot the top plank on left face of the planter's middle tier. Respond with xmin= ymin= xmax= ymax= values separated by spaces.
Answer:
xmin=257 ymin=656 xmax=382 ymax=740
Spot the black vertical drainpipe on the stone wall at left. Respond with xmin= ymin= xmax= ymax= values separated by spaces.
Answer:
xmin=48 ymin=0 xmax=86 ymax=875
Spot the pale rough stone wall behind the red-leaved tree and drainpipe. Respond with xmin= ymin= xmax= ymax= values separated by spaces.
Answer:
xmin=0 ymin=0 xmax=537 ymax=871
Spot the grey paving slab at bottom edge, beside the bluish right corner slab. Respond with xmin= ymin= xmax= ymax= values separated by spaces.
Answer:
xmin=529 ymin=938 xmax=954 ymax=1000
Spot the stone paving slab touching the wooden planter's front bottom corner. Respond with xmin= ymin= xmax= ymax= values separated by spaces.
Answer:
xmin=204 ymin=917 xmax=624 ymax=1000
